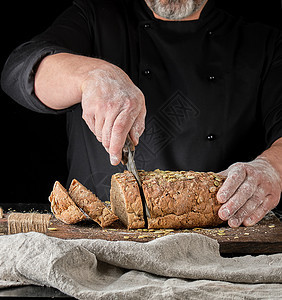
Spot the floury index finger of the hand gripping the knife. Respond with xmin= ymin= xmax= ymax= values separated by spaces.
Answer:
xmin=109 ymin=111 xmax=135 ymax=166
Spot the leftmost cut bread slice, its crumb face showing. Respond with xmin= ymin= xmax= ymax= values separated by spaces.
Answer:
xmin=49 ymin=181 xmax=87 ymax=224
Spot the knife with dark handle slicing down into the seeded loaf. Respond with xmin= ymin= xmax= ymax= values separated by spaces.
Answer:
xmin=121 ymin=135 xmax=151 ymax=218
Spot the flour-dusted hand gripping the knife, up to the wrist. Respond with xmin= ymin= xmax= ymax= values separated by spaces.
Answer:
xmin=81 ymin=62 xmax=146 ymax=165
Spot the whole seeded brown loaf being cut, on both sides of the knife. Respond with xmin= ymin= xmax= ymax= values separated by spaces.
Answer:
xmin=111 ymin=170 xmax=224 ymax=229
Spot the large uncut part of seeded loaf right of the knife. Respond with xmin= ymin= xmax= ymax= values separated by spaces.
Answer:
xmin=139 ymin=170 xmax=225 ymax=229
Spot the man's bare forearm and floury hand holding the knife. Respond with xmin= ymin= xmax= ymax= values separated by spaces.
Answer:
xmin=35 ymin=53 xmax=146 ymax=165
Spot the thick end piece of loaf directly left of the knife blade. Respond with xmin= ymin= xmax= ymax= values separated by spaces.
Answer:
xmin=110 ymin=171 xmax=145 ymax=229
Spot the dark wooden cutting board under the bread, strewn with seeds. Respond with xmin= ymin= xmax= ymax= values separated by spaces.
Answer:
xmin=0 ymin=213 xmax=282 ymax=256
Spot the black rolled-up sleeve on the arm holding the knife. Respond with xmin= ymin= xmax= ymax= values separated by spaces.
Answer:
xmin=1 ymin=0 xmax=94 ymax=114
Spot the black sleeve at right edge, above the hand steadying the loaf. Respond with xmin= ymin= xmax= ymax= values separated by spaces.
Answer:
xmin=261 ymin=32 xmax=282 ymax=147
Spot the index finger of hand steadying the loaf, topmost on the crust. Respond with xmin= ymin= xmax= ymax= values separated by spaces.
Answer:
xmin=217 ymin=163 xmax=247 ymax=203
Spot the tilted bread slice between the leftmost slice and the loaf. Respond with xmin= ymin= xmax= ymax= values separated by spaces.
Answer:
xmin=69 ymin=179 xmax=118 ymax=227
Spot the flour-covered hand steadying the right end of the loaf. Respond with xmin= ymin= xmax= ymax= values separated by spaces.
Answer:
xmin=217 ymin=158 xmax=282 ymax=227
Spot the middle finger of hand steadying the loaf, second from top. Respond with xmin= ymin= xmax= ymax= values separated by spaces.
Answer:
xmin=218 ymin=176 xmax=257 ymax=220
